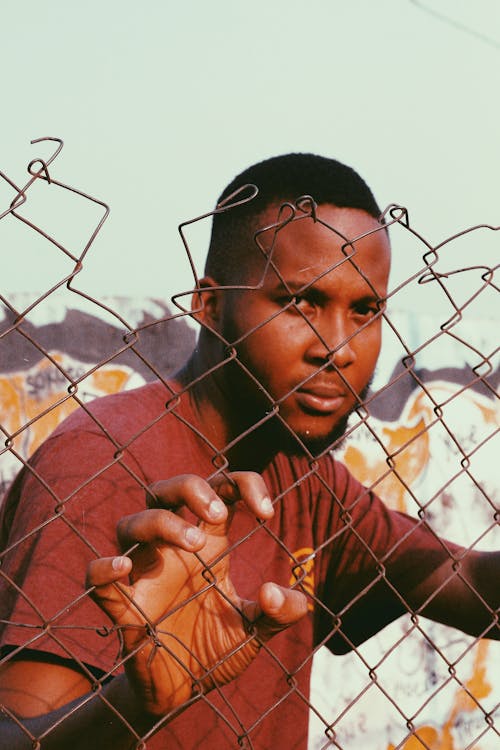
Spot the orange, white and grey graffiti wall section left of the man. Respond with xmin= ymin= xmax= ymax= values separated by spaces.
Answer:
xmin=0 ymin=295 xmax=195 ymax=501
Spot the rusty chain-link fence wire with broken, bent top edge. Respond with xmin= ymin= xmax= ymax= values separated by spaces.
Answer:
xmin=0 ymin=138 xmax=500 ymax=750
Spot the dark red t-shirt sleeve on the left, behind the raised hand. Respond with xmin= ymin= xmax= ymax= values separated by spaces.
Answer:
xmin=0 ymin=431 xmax=145 ymax=672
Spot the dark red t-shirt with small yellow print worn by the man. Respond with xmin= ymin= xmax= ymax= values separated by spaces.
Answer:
xmin=0 ymin=383 xmax=458 ymax=750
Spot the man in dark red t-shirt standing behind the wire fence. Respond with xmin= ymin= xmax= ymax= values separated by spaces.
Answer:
xmin=1 ymin=154 xmax=500 ymax=750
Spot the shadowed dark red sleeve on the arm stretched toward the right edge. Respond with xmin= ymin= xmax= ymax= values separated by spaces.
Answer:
xmin=314 ymin=461 xmax=461 ymax=653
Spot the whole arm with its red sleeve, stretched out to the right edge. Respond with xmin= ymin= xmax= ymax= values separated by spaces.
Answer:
xmin=318 ymin=488 xmax=500 ymax=654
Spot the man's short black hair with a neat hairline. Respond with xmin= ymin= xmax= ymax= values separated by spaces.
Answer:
xmin=205 ymin=153 xmax=381 ymax=285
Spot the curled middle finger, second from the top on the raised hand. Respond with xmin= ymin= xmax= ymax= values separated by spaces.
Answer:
xmin=146 ymin=474 xmax=227 ymax=523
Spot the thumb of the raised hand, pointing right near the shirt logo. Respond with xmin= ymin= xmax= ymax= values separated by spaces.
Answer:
xmin=243 ymin=583 xmax=307 ymax=641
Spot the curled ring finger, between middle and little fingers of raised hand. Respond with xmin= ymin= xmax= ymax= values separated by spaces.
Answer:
xmin=116 ymin=509 xmax=206 ymax=552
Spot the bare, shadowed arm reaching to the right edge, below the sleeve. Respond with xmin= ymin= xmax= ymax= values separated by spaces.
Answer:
xmin=321 ymin=548 xmax=500 ymax=654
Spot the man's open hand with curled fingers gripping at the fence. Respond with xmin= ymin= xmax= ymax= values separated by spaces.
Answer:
xmin=87 ymin=472 xmax=307 ymax=716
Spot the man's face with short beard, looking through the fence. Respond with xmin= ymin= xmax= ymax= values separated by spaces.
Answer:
xmin=215 ymin=205 xmax=390 ymax=456
